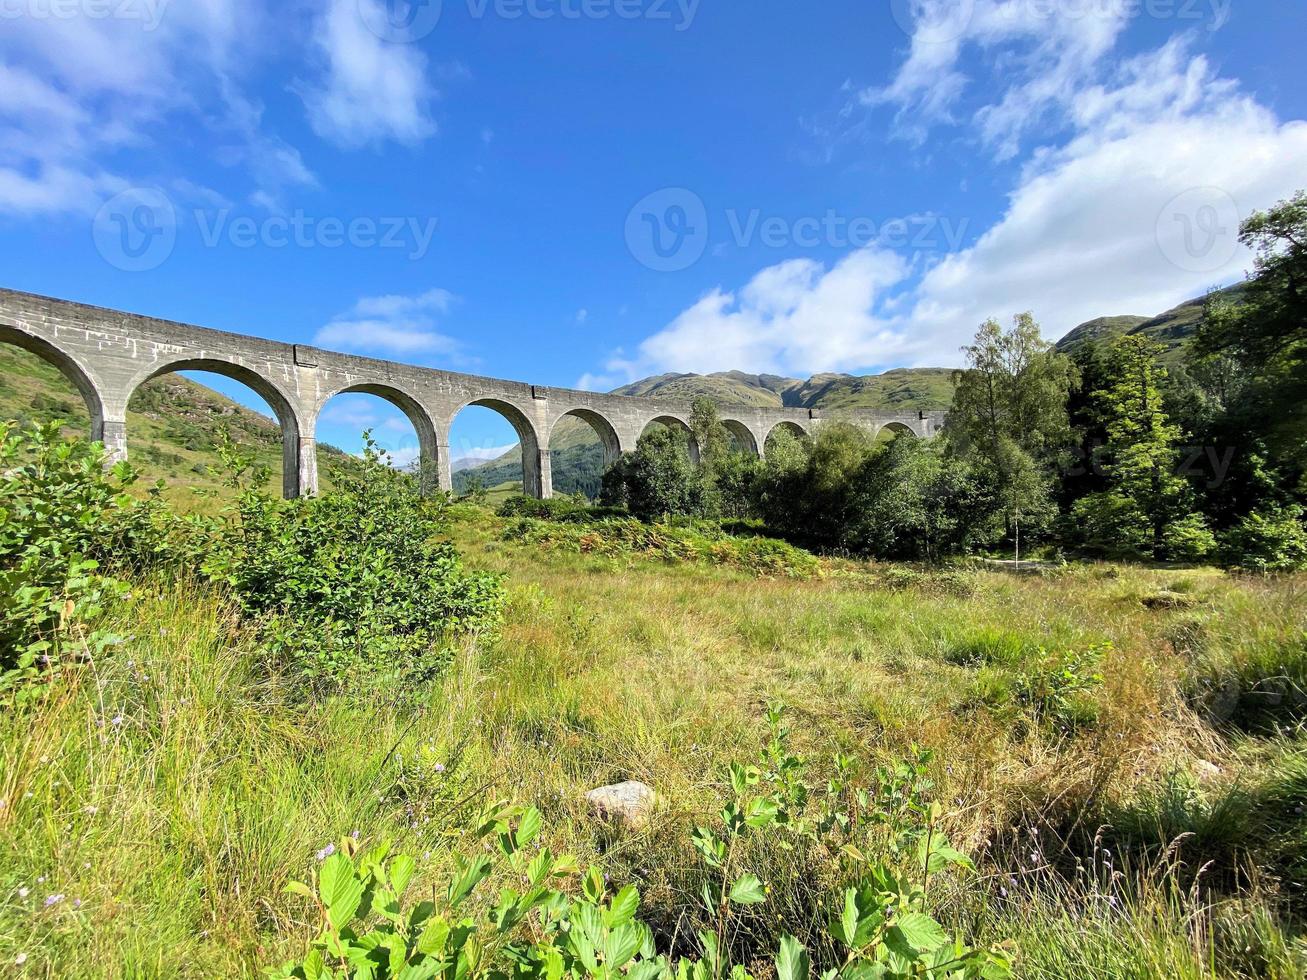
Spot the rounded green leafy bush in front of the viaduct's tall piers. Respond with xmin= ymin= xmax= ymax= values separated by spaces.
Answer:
xmin=203 ymin=439 xmax=503 ymax=682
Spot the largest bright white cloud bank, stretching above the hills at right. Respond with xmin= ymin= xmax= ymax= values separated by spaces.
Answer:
xmin=603 ymin=34 xmax=1307 ymax=385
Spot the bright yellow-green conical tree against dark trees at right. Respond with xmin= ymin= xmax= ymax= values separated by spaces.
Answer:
xmin=1072 ymin=336 xmax=1214 ymax=559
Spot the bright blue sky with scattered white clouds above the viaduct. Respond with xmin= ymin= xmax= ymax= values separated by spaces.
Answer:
xmin=0 ymin=0 xmax=1307 ymax=455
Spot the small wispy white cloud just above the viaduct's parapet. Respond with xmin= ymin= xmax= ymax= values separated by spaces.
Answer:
xmin=314 ymin=289 xmax=459 ymax=355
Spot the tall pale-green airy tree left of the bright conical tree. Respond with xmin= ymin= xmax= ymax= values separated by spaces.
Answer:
xmin=946 ymin=314 xmax=1076 ymax=549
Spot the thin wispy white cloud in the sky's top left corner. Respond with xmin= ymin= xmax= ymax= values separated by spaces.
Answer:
xmin=0 ymin=0 xmax=314 ymax=214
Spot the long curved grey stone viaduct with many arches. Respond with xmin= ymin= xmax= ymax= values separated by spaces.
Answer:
xmin=0 ymin=289 xmax=944 ymax=497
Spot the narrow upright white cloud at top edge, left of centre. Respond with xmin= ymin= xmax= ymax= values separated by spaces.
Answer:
xmin=301 ymin=0 xmax=435 ymax=148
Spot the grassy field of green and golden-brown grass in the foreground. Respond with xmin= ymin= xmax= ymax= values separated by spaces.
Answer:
xmin=0 ymin=506 xmax=1307 ymax=977
